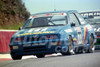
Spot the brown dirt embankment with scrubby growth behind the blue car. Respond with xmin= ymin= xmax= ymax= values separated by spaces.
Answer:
xmin=0 ymin=0 xmax=30 ymax=28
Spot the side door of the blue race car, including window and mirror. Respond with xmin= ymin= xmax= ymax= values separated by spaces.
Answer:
xmin=69 ymin=13 xmax=84 ymax=45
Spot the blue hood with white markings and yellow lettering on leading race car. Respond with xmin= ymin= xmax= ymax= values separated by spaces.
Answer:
xmin=13 ymin=26 xmax=67 ymax=37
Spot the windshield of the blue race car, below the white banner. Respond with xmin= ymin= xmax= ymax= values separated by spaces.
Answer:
xmin=23 ymin=15 xmax=66 ymax=28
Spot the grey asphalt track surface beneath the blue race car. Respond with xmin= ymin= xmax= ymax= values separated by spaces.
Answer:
xmin=0 ymin=50 xmax=100 ymax=67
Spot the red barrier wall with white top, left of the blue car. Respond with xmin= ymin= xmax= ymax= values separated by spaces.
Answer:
xmin=0 ymin=30 xmax=17 ymax=53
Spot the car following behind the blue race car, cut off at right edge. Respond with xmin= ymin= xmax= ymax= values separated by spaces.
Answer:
xmin=84 ymin=16 xmax=100 ymax=45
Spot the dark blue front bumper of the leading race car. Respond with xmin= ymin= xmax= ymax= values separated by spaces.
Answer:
xmin=10 ymin=41 xmax=68 ymax=55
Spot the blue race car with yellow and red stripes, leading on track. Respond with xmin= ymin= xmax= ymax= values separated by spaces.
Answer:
xmin=9 ymin=10 xmax=96 ymax=60
